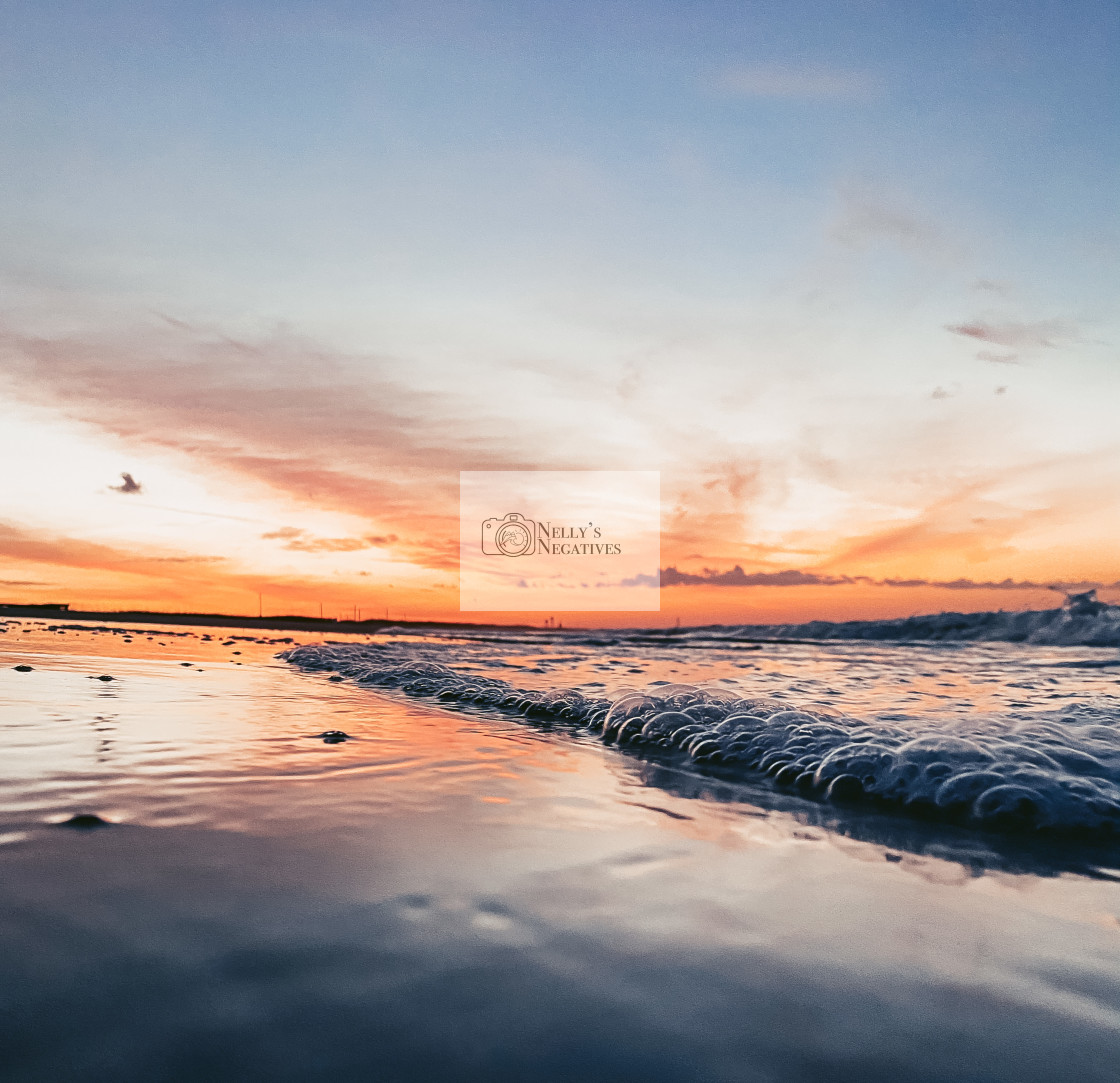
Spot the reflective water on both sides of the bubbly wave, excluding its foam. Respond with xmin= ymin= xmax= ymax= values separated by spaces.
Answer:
xmin=0 ymin=623 xmax=1120 ymax=1081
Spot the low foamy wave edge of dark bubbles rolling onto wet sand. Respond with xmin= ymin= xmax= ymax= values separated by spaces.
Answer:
xmin=280 ymin=644 xmax=1120 ymax=837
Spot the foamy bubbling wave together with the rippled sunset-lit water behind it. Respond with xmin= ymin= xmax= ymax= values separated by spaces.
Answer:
xmin=281 ymin=634 xmax=1120 ymax=846
